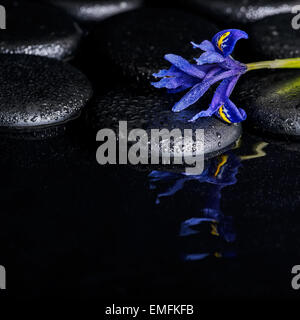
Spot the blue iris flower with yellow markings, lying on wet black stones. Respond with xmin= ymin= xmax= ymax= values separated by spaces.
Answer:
xmin=151 ymin=29 xmax=248 ymax=123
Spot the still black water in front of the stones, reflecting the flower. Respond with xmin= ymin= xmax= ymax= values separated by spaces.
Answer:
xmin=0 ymin=126 xmax=300 ymax=302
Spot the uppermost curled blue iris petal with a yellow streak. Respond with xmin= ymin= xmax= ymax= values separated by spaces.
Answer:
xmin=212 ymin=29 xmax=248 ymax=57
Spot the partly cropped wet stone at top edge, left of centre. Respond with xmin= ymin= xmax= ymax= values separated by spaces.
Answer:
xmin=39 ymin=0 xmax=143 ymax=22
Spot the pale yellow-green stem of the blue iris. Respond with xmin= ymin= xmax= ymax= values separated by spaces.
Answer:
xmin=246 ymin=57 xmax=300 ymax=71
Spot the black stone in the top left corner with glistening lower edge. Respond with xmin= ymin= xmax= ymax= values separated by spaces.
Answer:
xmin=0 ymin=1 xmax=82 ymax=60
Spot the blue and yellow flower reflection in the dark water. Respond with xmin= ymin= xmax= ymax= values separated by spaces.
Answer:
xmin=149 ymin=153 xmax=241 ymax=260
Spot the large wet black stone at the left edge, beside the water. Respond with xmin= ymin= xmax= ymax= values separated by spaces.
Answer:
xmin=0 ymin=55 xmax=92 ymax=130
